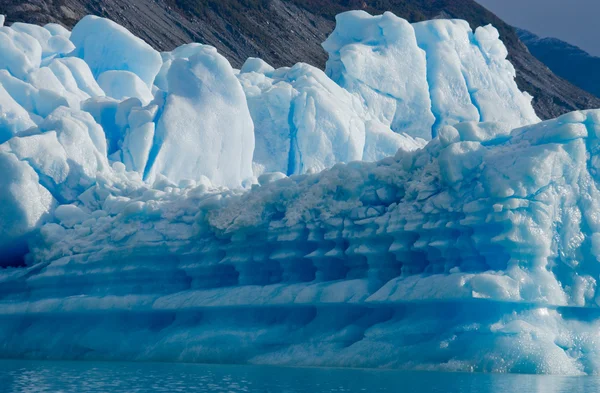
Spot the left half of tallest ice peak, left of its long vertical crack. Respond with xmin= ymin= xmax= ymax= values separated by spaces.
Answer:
xmin=323 ymin=11 xmax=435 ymax=139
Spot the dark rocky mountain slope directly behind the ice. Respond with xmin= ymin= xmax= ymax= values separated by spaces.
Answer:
xmin=0 ymin=0 xmax=600 ymax=118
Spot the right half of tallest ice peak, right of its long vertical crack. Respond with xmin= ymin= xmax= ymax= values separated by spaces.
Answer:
xmin=414 ymin=20 xmax=539 ymax=127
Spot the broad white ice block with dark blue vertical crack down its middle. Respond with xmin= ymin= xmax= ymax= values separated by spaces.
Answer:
xmin=239 ymin=63 xmax=376 ymax=175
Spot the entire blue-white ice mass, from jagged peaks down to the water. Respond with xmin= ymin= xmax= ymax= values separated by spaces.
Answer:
xmin=0 ymin=11 xmax=600 ymax=375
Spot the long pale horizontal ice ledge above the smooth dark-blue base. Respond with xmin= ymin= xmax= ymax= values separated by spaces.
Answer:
xmin=0 ymin=274 xmax=528 ymax=315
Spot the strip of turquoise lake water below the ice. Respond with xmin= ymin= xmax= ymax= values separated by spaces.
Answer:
xmin=0 ymin=360 xmax=600 ymax=393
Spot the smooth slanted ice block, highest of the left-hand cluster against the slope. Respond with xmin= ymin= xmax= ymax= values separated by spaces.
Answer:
xmin=70 ymin=15 xmax=162 ymax=87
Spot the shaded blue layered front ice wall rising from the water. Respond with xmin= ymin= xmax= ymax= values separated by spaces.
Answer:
xmin=0 ymin=111 xmax=600 ymax=374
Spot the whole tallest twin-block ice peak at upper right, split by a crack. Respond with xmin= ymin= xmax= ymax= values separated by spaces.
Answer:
xmin=323 ymin=11 xmax=539 ymax=140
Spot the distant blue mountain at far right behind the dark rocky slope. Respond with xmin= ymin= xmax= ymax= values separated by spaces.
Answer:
xmin=516 ymin=29 xmax=600 ymax=97
